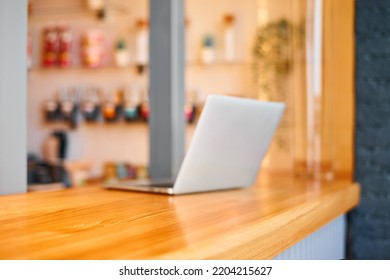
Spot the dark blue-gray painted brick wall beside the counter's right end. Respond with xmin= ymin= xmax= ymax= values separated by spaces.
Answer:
xmin=350 ymin=0 xmax=390 ymax=259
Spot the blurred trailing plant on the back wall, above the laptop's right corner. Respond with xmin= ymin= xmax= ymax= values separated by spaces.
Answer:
xmin=252 ymin=19 xmax=300 ymax=152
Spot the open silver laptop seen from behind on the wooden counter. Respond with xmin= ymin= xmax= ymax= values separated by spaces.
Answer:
xmin=105 ymin=95 xmax=285 ymax=195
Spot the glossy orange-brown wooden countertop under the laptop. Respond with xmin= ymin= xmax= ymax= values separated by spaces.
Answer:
xmin=0 ymin=174 xmax=359 ymax=259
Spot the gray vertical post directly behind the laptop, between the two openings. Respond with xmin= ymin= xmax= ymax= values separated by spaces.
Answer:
xmin=149 ymin=0 xmax=185 ymax=179
